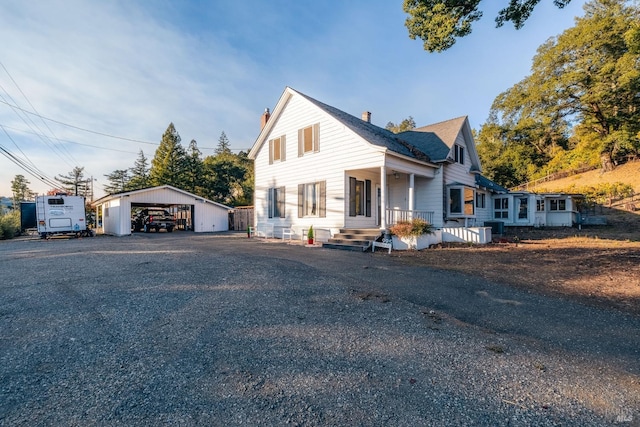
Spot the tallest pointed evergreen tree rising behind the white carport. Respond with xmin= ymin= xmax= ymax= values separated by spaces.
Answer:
xmin=149 ymin=123 xmax=187 ymax=188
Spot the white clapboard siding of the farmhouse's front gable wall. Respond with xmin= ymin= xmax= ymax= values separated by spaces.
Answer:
xmin=254 ymin=95 xmax=384 ymax=236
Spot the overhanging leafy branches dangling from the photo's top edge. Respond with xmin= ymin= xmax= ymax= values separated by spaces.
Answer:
xmin=403 ymin=0 xmax=571 ymax=52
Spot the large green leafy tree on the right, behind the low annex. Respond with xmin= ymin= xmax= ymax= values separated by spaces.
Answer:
xmin=478 ymin=0 xmax=640 ymax=187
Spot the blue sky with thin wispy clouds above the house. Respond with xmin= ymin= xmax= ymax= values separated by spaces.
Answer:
xmin=0 ymin=0 xmax=585 ymax=197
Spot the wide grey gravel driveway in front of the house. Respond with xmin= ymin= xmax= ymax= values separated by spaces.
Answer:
xmin=0 ymin=232 xmax=640 ymax=426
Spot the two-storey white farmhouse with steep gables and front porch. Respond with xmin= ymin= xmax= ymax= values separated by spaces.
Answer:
xmin=249 ymin=87 xmax=584 ymax=243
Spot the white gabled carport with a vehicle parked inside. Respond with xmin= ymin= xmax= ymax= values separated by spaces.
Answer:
xmin=91 ymin=185 xmax=231 ymax=236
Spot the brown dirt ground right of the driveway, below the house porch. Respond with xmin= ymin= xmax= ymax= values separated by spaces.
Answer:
xmin=393 ymin=211 xmax=640 ymax=316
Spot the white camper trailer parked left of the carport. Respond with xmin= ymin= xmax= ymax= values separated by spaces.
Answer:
xmin=36 ymin=194 xmax=93 ymax=239
